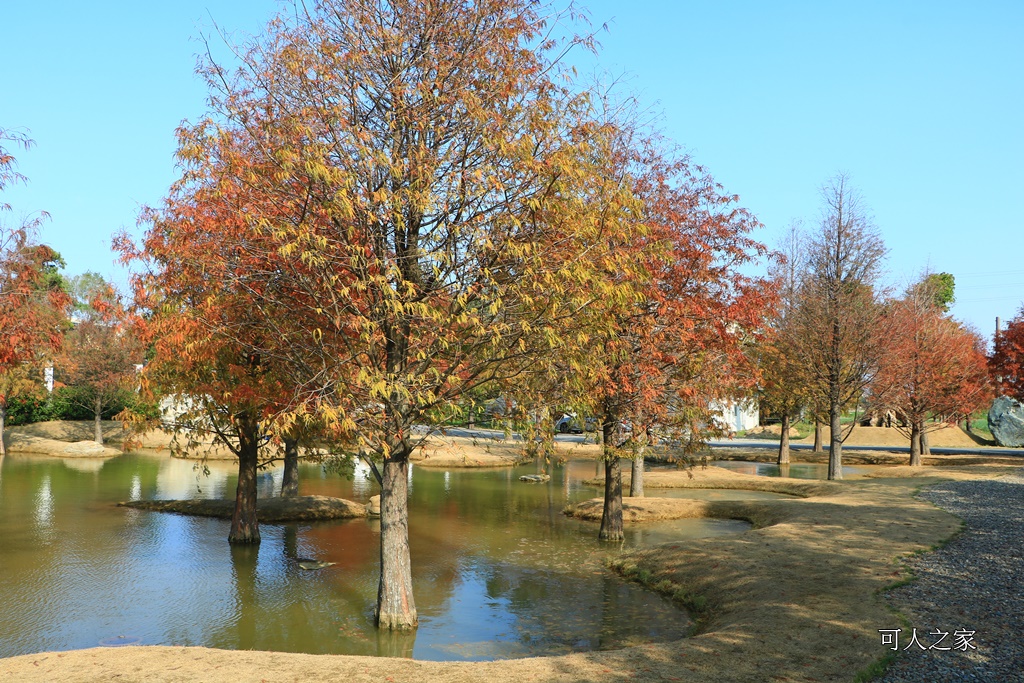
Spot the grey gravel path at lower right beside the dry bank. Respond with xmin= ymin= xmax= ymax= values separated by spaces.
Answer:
xmin=878 ymin=474 xmax=1024 ymax=683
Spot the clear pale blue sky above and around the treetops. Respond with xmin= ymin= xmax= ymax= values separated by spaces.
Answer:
xmin=0 ymin=0 xmax=1024 ymax=336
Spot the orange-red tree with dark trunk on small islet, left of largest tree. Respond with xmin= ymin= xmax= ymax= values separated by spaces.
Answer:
xmin=119 ymin=121 xmax=323 ymax=544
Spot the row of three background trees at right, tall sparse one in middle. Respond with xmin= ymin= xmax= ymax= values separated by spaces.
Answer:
xmin=757 ymin=175 xmax=992 ymax=479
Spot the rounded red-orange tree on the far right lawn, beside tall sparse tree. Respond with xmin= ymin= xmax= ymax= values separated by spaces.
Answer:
xmin=871 ymin=276 xmax=991 ymax=466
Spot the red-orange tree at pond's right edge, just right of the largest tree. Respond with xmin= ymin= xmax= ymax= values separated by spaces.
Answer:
xmin=574 ymin=124 xmax=772 ymax=541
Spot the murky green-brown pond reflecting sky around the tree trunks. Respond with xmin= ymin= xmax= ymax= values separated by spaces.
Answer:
xmin=0 ymin=454 xmax=749 ymax=660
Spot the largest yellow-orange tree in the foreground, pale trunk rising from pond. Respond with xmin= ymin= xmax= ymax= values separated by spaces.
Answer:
xmin=134 ymin=0 xmax=630 ymax=629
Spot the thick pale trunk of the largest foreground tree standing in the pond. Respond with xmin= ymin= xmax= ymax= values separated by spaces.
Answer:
xmin=377 ymin=454 xmax=419 ymax=631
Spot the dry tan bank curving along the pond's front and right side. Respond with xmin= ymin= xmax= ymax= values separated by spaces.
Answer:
xmin=0 ymin=419 xmax=1020 ymax=683
